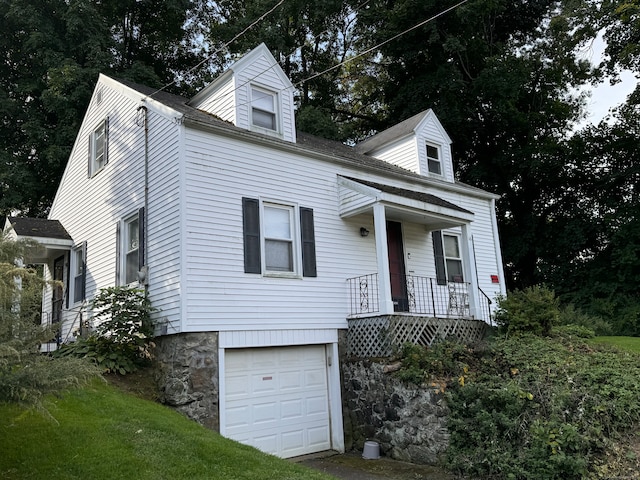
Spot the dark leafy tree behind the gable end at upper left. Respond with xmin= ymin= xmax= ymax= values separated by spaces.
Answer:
xmin=0 ymin=0 xmax=207 ymax=216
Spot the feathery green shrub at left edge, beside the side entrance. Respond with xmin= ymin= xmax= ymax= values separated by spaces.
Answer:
xmin=0 ymin=231 xmax=98 ymax=408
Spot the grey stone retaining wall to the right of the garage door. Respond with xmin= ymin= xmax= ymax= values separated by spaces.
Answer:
xmin=341 ymin=358 xmax=449 ymax=464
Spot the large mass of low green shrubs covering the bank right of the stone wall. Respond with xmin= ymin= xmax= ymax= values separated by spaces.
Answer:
xmin=447 ymin=334 xmax=640 ymax=480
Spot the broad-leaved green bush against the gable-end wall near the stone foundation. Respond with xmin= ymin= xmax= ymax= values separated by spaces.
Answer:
xmin=58 ymin=286 xmax=155 ymax=375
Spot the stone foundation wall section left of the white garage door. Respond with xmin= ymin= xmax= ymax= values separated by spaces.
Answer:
xmin=155 ymin=332 xmax=220 ymax=431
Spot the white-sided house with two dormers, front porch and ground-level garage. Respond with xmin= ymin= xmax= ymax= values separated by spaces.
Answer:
xmin=7 ymin=44 xmax=505 ymax=457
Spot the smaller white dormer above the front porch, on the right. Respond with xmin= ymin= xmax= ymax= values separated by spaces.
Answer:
xmin=356 ymin=109 xmax=454 ymax=182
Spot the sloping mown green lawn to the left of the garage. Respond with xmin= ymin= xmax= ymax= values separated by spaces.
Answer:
xmin=0 ymin=381 xmax=333 ymax=480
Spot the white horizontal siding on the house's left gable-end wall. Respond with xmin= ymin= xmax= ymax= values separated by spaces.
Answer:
xmin=49 ymin=77 xmax=182 ymax=331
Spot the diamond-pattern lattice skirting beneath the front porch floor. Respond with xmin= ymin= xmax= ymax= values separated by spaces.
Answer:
xmin=347 ymin=315 xmax=487 ymax=358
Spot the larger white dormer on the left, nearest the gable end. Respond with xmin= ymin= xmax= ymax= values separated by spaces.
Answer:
xmin=189 ymin=43 xmax=296 ymax=143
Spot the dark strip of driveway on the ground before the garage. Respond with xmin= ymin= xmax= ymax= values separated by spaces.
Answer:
xmin=295 ymin=452 xmax=455 ymax=480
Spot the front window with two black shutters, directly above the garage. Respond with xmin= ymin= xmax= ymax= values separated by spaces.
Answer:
xmin=242 ymin=198 xmax=317 ymax=277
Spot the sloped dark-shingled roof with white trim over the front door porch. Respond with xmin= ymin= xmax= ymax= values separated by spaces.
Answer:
xmin=338 ymin=175 xmax=474 ymax=229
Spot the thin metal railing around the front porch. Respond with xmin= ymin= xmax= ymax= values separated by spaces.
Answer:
xmin=347 ymin=273 xmax=491 ymax=322
